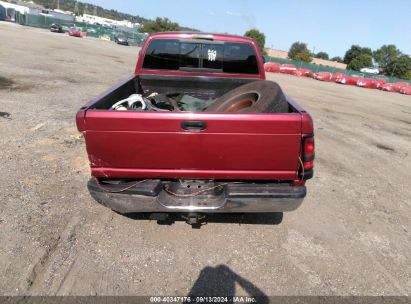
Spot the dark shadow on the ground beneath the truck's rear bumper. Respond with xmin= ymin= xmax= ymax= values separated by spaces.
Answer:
xmin=123 ymin=212 xmax=283 ymax=228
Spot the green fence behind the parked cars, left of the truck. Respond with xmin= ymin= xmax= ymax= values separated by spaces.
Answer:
xmin=16 ymin=12 xmax=146 ymax=46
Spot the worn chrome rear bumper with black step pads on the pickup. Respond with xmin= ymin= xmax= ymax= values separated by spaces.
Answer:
xmin=88 ymin=179 xmax=306 ymax=214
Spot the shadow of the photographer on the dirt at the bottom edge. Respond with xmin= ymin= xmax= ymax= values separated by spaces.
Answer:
xmin=188 ymin=265 xmax=269 ymax=303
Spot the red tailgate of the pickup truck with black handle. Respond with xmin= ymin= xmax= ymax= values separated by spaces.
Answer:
xmin=77 ymin=110 xmax=301 ymax=180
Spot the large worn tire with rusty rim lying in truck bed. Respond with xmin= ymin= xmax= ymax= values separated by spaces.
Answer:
xmin=205 ymin=80 xmax=288 ymax=113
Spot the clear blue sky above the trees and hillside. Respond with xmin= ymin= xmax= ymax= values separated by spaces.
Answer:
xmin=86 ymin=0 xmax=411 ymax=56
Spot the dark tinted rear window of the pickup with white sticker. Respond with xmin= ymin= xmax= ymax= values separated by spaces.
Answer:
xmin=143 ymin=39 xmax=259 ymax=74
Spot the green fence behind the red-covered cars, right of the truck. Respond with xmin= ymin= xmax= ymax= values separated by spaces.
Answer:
xmin=264 ymin=56 xmax=411 ymax=84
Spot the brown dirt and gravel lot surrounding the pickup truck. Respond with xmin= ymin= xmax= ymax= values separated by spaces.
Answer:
xmin=0 ymin=23 xmax=411 ymax=296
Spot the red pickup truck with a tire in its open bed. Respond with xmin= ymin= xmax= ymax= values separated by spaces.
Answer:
xmin=76 ymin=32 xmax=314 ymax=222
